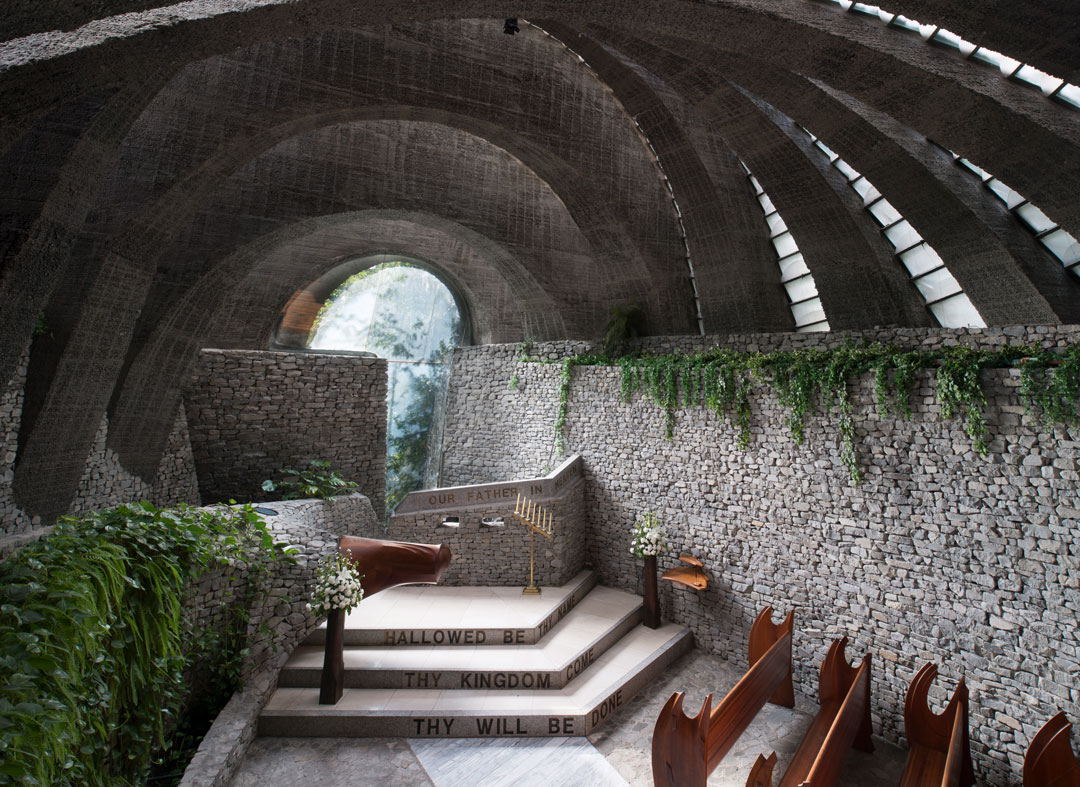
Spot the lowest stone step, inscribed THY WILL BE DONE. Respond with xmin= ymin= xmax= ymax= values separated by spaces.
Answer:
xmin=258 ymin=623 xmax=692 ymax=737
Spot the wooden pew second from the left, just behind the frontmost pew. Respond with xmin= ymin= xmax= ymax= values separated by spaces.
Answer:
xmin=746 ymin=637 xmax=874 ymax=787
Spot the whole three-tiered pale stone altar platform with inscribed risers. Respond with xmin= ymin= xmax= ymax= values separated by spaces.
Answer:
xmin=259 ymin=571 xmax=692 ymax=737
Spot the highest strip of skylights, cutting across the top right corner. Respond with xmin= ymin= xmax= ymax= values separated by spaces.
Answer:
xmin=821 ymin=0 xmax=1080 ymax=109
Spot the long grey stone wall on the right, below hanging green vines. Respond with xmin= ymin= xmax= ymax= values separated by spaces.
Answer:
xmin=444 ymin=326 xmax=1080 ymax=784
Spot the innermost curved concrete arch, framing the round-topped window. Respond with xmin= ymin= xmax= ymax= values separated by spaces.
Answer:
xmin=109 ymin=211 xmax=566 ymax=472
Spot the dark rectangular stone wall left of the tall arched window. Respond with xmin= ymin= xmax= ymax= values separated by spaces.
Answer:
xmin=185 ymin=350 xmax=387 ymax=517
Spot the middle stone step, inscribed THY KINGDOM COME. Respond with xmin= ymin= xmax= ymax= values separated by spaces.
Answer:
xmin=278 ymin=587 xmax=642 ymax=690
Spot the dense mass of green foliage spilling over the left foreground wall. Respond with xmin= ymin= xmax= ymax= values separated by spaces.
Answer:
xmin=0 ymin=502 xmax=287 ymax=787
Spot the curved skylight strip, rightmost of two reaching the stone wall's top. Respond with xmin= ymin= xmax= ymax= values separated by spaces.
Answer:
xmin=799 ymin=126 xmax=986 ymax=328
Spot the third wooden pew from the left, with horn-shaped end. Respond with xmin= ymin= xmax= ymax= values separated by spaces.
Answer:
xmin=900 ymin=664 xmax=975 ymax=787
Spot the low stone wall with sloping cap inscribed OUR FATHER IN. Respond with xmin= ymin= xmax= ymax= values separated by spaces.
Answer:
xmin=387 ymin=458 xmax=586 ymax=585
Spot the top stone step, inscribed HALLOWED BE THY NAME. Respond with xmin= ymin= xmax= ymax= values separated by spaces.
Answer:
xmin=305 ymin=570 xmax=596 ymax=647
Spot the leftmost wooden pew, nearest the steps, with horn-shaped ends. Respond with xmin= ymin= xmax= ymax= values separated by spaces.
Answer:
xmin=652 ymin=607 xmax=795 ymax=787
